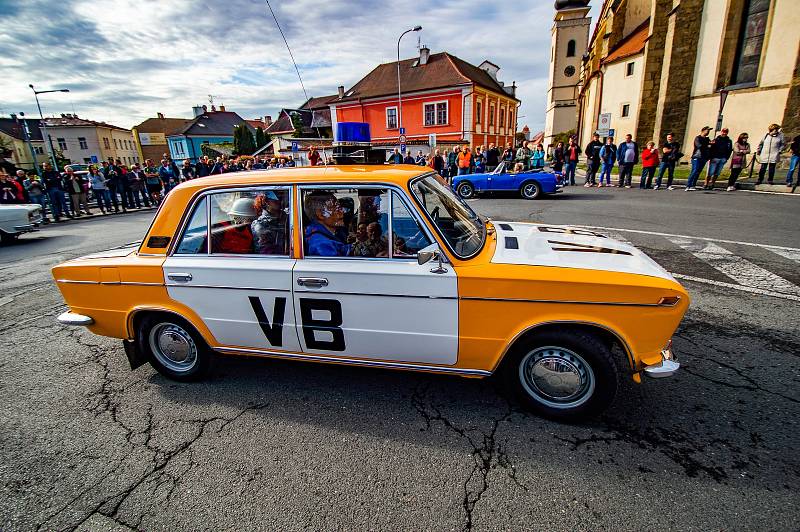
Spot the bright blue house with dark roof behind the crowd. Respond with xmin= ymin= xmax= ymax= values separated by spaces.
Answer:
xmin=167 ymin=105 xmax=254 ymax=163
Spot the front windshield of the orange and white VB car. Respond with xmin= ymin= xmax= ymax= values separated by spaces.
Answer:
xmin=411 ymin=175 xmax=486 ymax=259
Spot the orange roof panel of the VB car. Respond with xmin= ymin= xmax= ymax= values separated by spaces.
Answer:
xmin=172 ymin=164 xmax=433 ymax=189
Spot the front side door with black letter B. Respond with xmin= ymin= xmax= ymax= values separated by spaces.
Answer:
xmin=293 ymin=185 xmax=458 ymax=365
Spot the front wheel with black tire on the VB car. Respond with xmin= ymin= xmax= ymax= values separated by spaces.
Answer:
xmin=503 ymin=330 xmax=620 ymax=421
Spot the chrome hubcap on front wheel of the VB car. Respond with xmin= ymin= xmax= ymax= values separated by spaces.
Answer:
xmin=519 ymin=346 xmax=595 ymax=409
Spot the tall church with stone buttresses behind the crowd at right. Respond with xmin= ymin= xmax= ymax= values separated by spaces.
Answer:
xmin=578 ymin=0 xmax=800 ymax=159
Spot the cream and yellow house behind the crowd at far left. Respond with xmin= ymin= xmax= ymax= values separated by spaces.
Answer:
xmin=39 ymin=114 xmax=140 ymax=166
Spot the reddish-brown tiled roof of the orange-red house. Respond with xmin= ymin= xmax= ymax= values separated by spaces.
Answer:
xmin=337 ymin=52 xmax=510 ymax=101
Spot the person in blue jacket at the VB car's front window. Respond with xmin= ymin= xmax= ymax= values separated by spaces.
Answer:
xmin=303 ymin=192 xmax=352 ymax=257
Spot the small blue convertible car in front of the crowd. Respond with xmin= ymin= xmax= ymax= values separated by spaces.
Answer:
xmin=452 ymin=162 xmax=561 ymax=199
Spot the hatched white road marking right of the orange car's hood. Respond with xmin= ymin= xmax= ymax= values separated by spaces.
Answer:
xmin=669 ymin=237 xmax=800 ymax=297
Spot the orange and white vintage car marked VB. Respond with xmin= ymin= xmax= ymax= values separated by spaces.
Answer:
xmin=53 ymin=165 xmax=689 ymax=418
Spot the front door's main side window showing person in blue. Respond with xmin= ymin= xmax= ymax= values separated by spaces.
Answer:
xmin=301 ymin=188 xmax=389 ymax=258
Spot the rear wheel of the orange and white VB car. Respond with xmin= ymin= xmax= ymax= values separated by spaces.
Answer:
xmin=136 ymin=314 xmax=215 ymax=382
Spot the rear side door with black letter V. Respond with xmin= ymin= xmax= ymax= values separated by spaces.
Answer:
xmin=163 ymin=186 xmax=300 ymax=352
